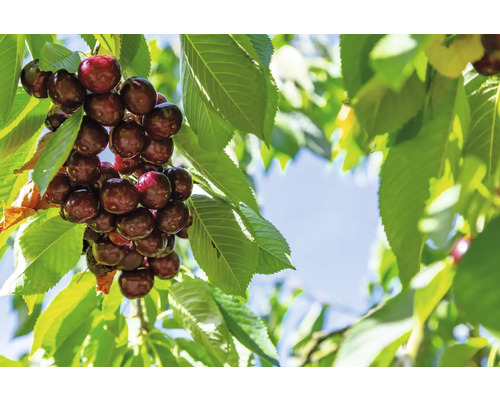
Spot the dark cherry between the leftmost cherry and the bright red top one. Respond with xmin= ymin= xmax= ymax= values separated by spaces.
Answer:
xmin=48 ymin=69 xmax=86 ymax=111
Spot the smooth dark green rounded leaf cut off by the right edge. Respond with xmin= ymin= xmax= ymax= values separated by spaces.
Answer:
xmin=453 ymin=217 xmax=500 ymax=331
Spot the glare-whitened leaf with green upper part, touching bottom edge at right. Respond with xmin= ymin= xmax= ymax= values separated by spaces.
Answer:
xmin=334 ymin=290 xmax=416 ymax=367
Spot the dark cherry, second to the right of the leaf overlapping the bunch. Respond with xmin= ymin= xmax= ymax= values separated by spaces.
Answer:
xmin=109 ymin=120 xmax=146 ymax=158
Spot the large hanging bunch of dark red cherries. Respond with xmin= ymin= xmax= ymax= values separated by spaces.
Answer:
xmin=21 ymin=55 xmax=193 ymax=299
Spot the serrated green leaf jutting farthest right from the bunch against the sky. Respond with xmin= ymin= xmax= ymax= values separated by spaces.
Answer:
xmin=240 ymin=206 xmax=295 ymax=274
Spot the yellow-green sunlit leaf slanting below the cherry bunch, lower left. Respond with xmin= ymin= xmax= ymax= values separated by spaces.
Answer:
xmin=30 ymin=274 xmax=100 ymax=355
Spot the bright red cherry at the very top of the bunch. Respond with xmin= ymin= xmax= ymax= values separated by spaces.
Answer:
xmin=78 ymin=54 xmax=122 ymax=93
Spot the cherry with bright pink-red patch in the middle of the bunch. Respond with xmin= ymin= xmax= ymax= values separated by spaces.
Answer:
xmin=136 ymin=171 xmax=171 ymax=209
